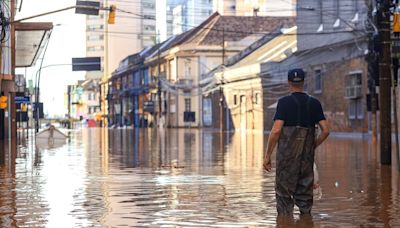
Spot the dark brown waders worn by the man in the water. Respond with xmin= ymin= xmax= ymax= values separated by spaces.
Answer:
xmin=275 ymin=127 xmax=315 ymax=215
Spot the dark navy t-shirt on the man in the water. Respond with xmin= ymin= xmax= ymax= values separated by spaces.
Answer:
xmin=274 ymin=92 xmax=325 ymax=127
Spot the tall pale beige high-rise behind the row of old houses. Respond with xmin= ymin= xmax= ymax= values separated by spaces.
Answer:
xmin=100 ymin=0 xmax=157 ymax=124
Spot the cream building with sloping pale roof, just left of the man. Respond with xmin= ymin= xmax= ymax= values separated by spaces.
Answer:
xmin=207 ymin=26 xmax=297 ymax=132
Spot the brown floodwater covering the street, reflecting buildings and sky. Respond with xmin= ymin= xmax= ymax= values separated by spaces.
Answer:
xmin=0 ymin=128 xmax=400 ymax=227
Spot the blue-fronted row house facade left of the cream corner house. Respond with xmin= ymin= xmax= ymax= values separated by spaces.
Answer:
xmin=107 ymin=45 xmax=164 ymax=128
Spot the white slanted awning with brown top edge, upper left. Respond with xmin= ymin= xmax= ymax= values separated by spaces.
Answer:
xmin=15 ymin=22 xmax=53 ymax=67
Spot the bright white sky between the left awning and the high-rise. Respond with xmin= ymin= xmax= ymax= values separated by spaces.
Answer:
xmin=16 ymin=0 xmax=86 ymax=117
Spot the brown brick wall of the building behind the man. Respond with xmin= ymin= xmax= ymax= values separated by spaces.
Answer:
xmin=264 ymin=57 xmax=368 ymax=132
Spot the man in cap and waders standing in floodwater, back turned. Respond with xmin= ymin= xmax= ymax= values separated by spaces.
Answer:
xmin=263 ymin=69 xmax=329 ymax=216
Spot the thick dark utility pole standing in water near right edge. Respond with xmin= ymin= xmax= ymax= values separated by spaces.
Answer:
xmin=377 ymin=1 xmax=392 ymax=165
